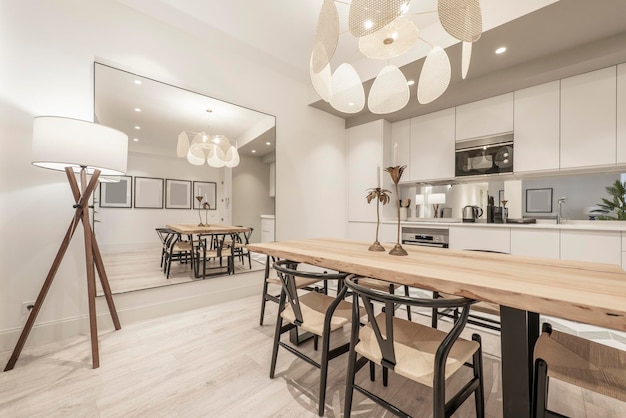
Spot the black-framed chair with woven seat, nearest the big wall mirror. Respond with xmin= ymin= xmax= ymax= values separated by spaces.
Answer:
xmin=270 ymin=260 xmax=358 ymax=416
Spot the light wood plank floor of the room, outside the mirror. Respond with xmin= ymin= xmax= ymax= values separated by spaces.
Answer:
xmin=0 ymin=272 xmax=626 ymax=418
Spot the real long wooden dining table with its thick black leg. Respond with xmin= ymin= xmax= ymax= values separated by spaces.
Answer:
xmin=248 ymin=238 xmax=626 ymax=418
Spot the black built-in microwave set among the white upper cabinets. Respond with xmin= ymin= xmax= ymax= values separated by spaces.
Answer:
xmin=455 ymin=134 xmax=513 ymax=177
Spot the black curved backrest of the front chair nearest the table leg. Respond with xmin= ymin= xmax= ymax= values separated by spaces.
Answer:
xmin=344 ymin=275 xmax=477 ymax=370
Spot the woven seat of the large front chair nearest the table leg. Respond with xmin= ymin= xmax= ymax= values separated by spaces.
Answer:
xmin=355 ymin=313 xmax=479 ymax=387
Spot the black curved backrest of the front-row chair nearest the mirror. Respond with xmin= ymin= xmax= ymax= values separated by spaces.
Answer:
xmin=274 ymin=260 xmax=347 ymax=325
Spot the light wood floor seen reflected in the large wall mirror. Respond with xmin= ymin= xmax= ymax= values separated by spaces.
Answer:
xmin=96 ymin=246 xmax=265 ymax=296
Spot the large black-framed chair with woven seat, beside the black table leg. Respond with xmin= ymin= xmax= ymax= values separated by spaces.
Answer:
xmin=344 ymin=275 xmax=485 ymax=418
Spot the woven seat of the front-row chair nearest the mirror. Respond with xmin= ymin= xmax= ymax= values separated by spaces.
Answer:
xmin=280 ymin=292 xmax=352 ymax=336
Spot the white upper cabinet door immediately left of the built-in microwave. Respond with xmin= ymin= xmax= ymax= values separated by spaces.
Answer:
xmin=409 ymin=108 xmax=455 ymax=181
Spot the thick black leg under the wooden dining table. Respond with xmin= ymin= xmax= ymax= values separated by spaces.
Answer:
xmin=500 ymin=306 xmax=539 ymax=418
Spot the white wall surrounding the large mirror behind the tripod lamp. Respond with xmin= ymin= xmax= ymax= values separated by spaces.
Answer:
xmin=0 ymin=0 xmax=346 ymax=349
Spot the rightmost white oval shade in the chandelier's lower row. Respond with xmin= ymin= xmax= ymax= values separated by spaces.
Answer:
xmin=417 ymin=46 xmax=452 ymax=104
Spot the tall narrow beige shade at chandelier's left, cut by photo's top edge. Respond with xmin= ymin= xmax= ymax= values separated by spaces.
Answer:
xmin=311 ymin=0 xmax=339 ymax=74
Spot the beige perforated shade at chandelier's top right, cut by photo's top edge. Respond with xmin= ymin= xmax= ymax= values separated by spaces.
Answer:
xmin=437 ymin=0 xmax=483 ymax=42
